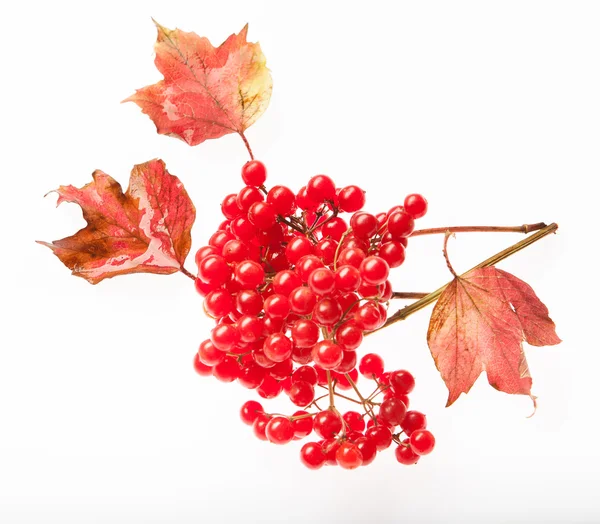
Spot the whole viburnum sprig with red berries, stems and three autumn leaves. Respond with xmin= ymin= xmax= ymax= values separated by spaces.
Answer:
xmin=41 ymin=20 xmax=560 ymax=469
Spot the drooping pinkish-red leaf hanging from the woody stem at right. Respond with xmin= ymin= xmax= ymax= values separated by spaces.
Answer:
xmin=427 ymin=267 xmax=560 ymax=406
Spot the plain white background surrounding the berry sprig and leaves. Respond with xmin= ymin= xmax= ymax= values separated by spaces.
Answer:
xmin=0 ymin=0 xmax=600 ymax=523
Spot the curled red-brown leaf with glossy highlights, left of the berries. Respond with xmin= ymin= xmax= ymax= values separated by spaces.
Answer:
xmin=39 ymin=160 xmax=196 ymax=284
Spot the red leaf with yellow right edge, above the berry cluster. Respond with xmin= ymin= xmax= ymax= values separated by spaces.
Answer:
xmin=124 ymin=24 xmax=273 ymax=146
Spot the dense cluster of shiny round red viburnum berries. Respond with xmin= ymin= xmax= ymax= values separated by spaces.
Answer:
xmin=194 ymin=160 xmax=435 ymax=469
